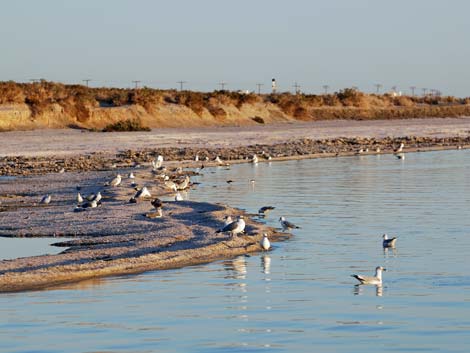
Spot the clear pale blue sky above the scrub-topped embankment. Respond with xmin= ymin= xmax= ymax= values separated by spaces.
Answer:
xmin=0 ymin=0 xmax=470 ymax=97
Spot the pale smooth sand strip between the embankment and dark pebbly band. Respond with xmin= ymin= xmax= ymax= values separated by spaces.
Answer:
xmin=0 ymin=117 xmax=470 ymax=157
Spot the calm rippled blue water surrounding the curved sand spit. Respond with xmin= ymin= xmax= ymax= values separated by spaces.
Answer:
xmin=0 ymin=151 xmax=470 ymax=352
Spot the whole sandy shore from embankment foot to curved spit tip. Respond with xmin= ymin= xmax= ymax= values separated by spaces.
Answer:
xmin=0 ymin=118 xmax=470 ymax=292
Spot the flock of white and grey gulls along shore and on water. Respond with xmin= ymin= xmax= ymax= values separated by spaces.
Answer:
xmin=35 ymin=143 xmax=405 ymax=286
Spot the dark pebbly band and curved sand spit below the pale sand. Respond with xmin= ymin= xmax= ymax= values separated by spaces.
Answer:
xmin=0 ymin=119 xmax=470 ymax=292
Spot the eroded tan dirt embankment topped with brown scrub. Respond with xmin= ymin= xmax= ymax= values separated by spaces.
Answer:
xmin=0 ymin=81 xmax=470 ymax=131
